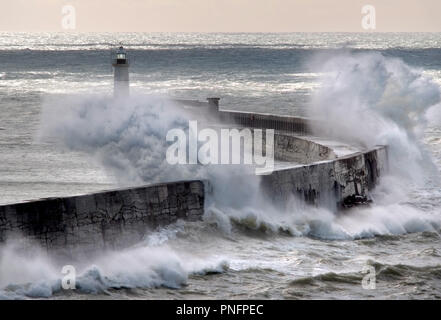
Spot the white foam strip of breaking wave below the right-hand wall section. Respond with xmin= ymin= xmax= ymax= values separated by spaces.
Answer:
xmin=207 ymin=188 xmax=441 ymax=240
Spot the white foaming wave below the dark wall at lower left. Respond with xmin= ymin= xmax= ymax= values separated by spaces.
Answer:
xmin=0 ymin=240 xmax=228 ymax=299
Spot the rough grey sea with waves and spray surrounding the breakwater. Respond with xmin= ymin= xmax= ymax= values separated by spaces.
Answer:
xmin=0 ymin=33 xmax=441 ymax=299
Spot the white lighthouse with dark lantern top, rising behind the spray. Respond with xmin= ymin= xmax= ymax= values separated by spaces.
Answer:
xmin=112 ymin=46 xmax=130 ymax=97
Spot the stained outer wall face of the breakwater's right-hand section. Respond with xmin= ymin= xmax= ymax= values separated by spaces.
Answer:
xmin=262 ymin=146 xmax=387 ymax=209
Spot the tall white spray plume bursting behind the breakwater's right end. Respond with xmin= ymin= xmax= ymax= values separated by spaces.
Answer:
xmin=308 ymin=51 xmax=440 ymax=183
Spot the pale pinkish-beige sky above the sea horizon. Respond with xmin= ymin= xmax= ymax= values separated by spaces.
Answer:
xmin=0 ymin=0 xmax=441 ymax=32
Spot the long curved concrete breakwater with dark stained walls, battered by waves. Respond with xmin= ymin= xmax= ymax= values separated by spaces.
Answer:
xmin=0 ymin=98 xmax=388 ymax=254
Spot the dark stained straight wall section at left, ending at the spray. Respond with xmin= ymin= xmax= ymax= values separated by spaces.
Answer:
xmin=0 ymin=180 xmax=204 ymax=252
